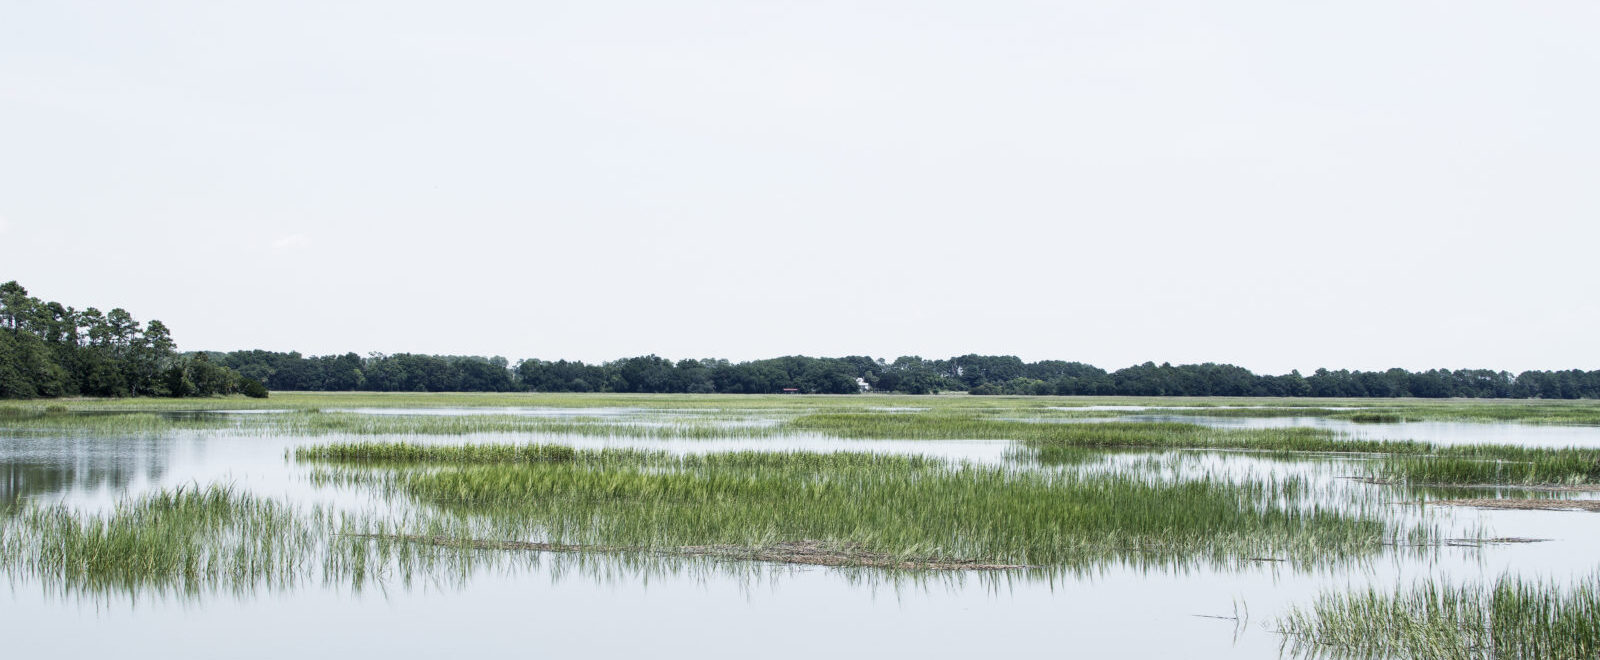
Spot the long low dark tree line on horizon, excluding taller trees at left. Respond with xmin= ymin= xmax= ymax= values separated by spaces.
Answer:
xmin=200 ymin=351 xmax=1600 ymax=399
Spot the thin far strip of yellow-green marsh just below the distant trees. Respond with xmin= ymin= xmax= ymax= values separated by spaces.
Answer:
xmin=12 ymin=392 xmax=1600 ymax=437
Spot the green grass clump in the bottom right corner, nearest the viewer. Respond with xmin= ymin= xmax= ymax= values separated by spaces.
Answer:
xmin=1277 ymin=573 xmax=1600 ymax=658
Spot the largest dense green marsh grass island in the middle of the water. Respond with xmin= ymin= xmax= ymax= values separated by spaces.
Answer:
xmin=305 ymin=447 xmax=1430 ymax=567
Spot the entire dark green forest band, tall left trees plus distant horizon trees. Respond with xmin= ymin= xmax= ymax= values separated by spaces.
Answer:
xmin=0 ymin=282 xmax=1600 ymax=399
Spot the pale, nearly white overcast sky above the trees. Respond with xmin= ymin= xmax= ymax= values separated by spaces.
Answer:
xmin=0 ymin=0 xmax=1600 ymax=373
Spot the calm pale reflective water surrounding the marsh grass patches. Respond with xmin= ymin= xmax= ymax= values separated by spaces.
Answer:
xmin=0 ymin=410 xmax=1600 ymax=660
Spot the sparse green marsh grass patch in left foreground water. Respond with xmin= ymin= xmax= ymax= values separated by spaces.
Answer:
xmin=0 ymin=485 xmax=556 ymax=601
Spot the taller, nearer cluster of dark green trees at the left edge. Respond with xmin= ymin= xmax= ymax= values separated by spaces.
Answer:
xmin=0 ymin=280 xmax=267 ymax=399
